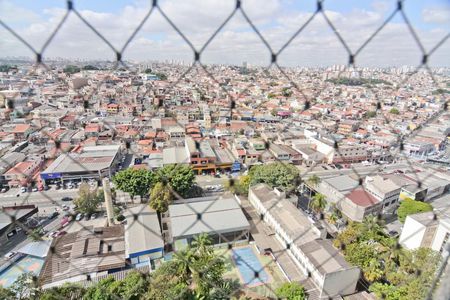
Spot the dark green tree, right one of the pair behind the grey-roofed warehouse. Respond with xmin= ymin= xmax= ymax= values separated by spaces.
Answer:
xmin=156 ymin=164 xmax=195 ymax=198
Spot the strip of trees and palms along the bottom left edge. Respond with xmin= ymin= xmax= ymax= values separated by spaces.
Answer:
xmin=0 ymin=234 xmax=240 ymax=300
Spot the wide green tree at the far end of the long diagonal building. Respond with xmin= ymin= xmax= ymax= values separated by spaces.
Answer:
xmin=249 ymin=162 xmax=299 ymax=193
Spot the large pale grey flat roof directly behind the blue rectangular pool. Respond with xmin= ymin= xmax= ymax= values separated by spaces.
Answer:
xmin=169 ymin=197 xmax=250 ymax=238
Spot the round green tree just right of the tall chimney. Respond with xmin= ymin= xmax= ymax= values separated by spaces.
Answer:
xmin=113 ymin=168 xmax=155 ymax=199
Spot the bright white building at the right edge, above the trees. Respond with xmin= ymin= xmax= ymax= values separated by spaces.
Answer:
xmin=399 ymin=211 xmax=450 ymax=254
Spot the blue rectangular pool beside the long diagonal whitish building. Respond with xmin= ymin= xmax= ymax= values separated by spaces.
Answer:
xmin=232 ymin=247 xmax=269 ymax=286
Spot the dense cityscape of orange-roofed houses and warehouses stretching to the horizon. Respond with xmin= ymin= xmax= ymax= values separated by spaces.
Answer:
xmin=0 ymin=60 xmax=450 ymax=299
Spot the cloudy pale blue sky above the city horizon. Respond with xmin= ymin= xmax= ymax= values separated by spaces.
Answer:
xmin=0 ymin=0 xmax=450 ymax=67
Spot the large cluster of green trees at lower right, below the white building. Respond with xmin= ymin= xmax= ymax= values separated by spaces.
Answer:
xmin=333 ymin=217 xmax=440 ymax=300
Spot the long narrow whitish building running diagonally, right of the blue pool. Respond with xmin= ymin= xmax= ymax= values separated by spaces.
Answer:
xmin=248 ymin=184 xmax=360 ymax=299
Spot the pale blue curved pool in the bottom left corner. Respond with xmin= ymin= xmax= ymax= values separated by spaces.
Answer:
xmin=0 ymin=255 xmax=44 ymax=288
